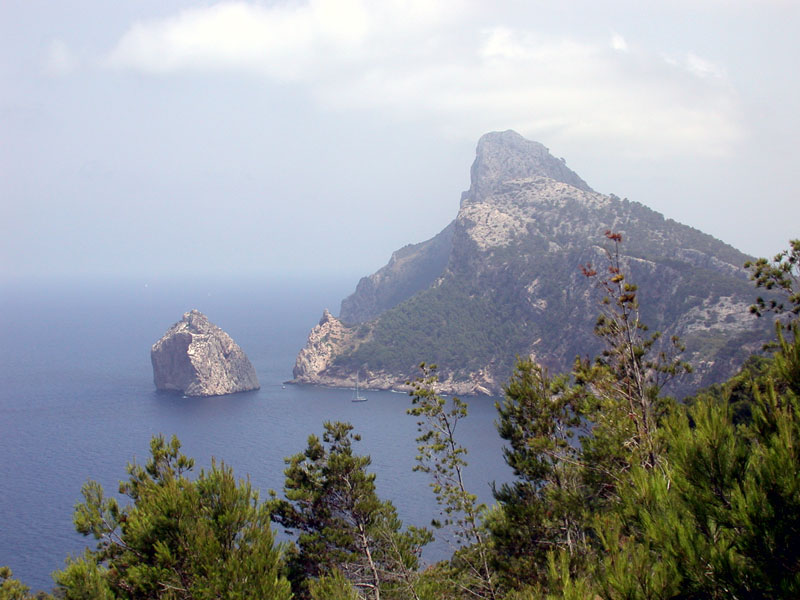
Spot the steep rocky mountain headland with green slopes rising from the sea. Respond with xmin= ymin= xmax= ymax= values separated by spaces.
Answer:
xmin=295 ymin=131 xmax=769 ymax=394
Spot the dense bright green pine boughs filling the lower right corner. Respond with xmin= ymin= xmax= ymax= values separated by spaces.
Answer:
xmin=584 ymin=325 xmax=800 ymax=598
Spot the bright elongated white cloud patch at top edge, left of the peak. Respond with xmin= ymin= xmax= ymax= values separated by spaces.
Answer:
xmin=105 ymin=0 xmax=454 ymax=80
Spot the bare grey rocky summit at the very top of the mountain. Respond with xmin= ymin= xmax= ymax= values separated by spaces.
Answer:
xmin=469 ymin=129 xmax=592 ymax=199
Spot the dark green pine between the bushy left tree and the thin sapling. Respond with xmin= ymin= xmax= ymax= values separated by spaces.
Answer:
xmin=271 ymin=422 xmax=431 ymax=600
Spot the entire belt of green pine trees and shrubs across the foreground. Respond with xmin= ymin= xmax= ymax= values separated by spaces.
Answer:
xmin=0 ymin=240 xmax=800 ymax=600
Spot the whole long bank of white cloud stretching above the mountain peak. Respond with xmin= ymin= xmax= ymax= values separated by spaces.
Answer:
xmin=105 ymin=0 xmax=741 ymax=155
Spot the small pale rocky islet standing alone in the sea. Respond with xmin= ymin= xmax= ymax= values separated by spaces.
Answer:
xmin=150 ymin=310 xmax=259 ymax=396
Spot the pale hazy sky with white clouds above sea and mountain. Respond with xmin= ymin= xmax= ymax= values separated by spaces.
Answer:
xmin=0 ymin=0 xmax=800 ymax=281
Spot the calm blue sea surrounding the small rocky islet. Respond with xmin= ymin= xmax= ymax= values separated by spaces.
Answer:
xmin=0 ymin=280 xmax=508 ymax=590
